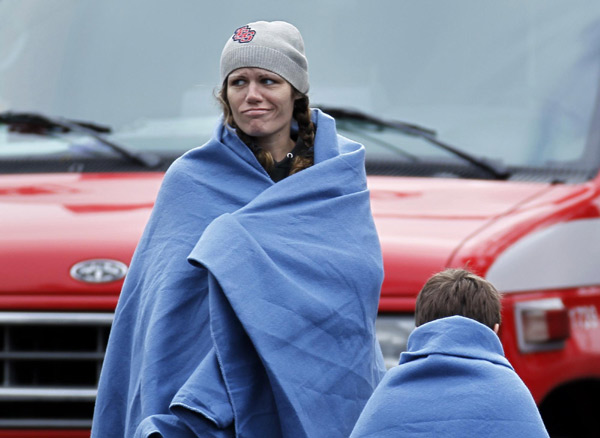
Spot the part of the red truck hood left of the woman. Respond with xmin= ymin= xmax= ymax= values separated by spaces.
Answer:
xmin=0 ymin=173 xmax=163 ymax=295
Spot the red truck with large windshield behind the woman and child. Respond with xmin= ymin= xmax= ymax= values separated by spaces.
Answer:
xmin=0 ymin=0 xmax=600 ymax=438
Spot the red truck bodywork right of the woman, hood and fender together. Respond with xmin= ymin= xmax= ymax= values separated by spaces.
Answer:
xmin=370 ymin=177 xmax=600 ymax=402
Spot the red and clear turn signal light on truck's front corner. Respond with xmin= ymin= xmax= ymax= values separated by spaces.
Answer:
xmin=515 ymin=298 xmax=571 ymax=353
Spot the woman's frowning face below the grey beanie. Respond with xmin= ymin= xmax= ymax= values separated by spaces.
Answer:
xmin=227 ymin=67 xmax=296 ymax=146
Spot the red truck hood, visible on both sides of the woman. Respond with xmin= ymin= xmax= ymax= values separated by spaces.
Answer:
xmin=0 ymin=172 xmax=576 ymax=308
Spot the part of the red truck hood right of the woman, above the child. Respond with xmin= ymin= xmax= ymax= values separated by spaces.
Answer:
xmin=369 ymin=177 xmax=573 ymax=309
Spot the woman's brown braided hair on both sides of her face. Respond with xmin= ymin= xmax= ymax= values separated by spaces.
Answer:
xmin=217 ymin=81 xmax=316 ymax=175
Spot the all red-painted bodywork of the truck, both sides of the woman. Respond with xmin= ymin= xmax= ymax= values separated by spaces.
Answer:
xmin=0 ymin=172 xmax=600 ymax=430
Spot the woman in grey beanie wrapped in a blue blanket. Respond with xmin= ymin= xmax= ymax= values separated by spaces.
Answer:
xmin=92 ymin=22 xmax=383 ymax=438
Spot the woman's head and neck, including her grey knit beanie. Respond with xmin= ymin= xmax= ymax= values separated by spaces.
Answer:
xmin=219 ymin=21 xmax=315 ymax=182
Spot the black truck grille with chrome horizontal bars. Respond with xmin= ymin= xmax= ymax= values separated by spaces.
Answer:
xmin=0 ymin=312 xmax=113 ymax=429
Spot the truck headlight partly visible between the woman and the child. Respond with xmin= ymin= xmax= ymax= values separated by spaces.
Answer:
xmin=375 ymin=314 xmax=415 ymax=369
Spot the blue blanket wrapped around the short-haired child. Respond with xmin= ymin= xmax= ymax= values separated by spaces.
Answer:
xmin=351 ymin=316 xmax=548 ymax=438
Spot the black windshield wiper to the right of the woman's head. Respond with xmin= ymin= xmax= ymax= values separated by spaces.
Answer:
xmin=318 ymin=106 xmax=510 ymax=179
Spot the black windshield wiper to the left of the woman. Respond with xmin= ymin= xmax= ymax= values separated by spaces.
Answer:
xmin=0 ymin=112 xmax=162 ymax=169
